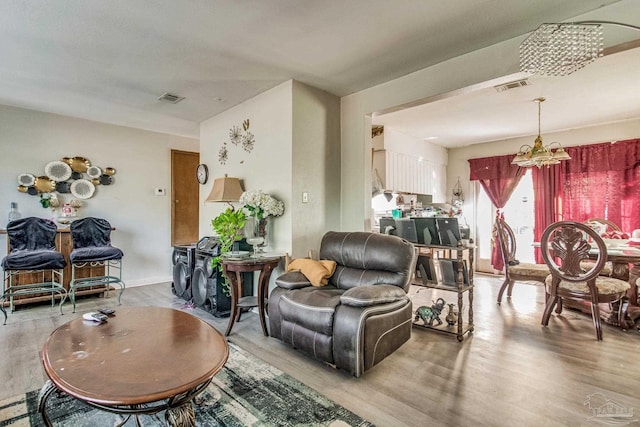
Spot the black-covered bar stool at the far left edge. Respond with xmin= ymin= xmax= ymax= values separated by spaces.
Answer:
xmin=0 ymin=217 xmax=67 ymax=324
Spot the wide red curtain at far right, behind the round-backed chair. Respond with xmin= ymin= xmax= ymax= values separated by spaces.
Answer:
xmin=557 ymin=139 xmax=640 ymax=232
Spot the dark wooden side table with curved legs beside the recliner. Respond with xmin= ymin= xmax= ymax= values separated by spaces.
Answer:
xmin=222 ymin=256 xmax=280 ymax=337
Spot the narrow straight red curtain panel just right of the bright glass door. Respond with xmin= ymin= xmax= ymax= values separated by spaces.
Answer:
xmin=532 ymin=166 xmax=562 ymax=264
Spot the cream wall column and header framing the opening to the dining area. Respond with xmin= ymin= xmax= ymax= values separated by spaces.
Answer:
xmin=341 ymin=0 xmax=640 ymax=230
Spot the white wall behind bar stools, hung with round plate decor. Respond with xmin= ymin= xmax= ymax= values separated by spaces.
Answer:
xmin=0 ymin=106 xmax=199 ymax=286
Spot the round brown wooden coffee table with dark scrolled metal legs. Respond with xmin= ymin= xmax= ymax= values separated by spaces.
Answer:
xmin=39 ymin=307 xmax=229 ymax=426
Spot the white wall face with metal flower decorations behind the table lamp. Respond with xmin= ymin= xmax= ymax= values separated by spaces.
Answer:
xmin=200 ymin=81 xmax=292 ymax=251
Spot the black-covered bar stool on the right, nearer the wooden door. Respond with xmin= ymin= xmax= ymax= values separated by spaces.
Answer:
xmin=69 ymin=217 xmax=125 ymax=313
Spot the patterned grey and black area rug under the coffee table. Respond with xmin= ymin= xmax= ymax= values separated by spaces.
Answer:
xmin=0 ymin=343 xmax=373 ymax=427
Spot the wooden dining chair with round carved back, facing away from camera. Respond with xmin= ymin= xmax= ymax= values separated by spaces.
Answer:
xmin=540 ymin=221 xmax=630 ymax=341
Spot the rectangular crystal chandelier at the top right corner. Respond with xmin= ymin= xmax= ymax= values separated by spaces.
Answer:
xmin=520 ymin=21 xmax=640 ymax=76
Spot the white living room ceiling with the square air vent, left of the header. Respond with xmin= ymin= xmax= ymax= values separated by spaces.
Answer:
xmin=0 ymin=0 xmax=638 ymax=140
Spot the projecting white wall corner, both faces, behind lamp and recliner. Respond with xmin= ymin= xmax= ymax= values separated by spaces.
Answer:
xmin=200 ymin=80 xmax=340 ymax=256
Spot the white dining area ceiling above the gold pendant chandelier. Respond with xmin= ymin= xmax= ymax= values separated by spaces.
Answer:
xmin=372 ymin=48 xmax=640 ymax=148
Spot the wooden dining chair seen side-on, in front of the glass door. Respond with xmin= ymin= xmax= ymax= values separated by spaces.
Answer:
xmin=496 ymin=218 xmax=550 ymax=304
